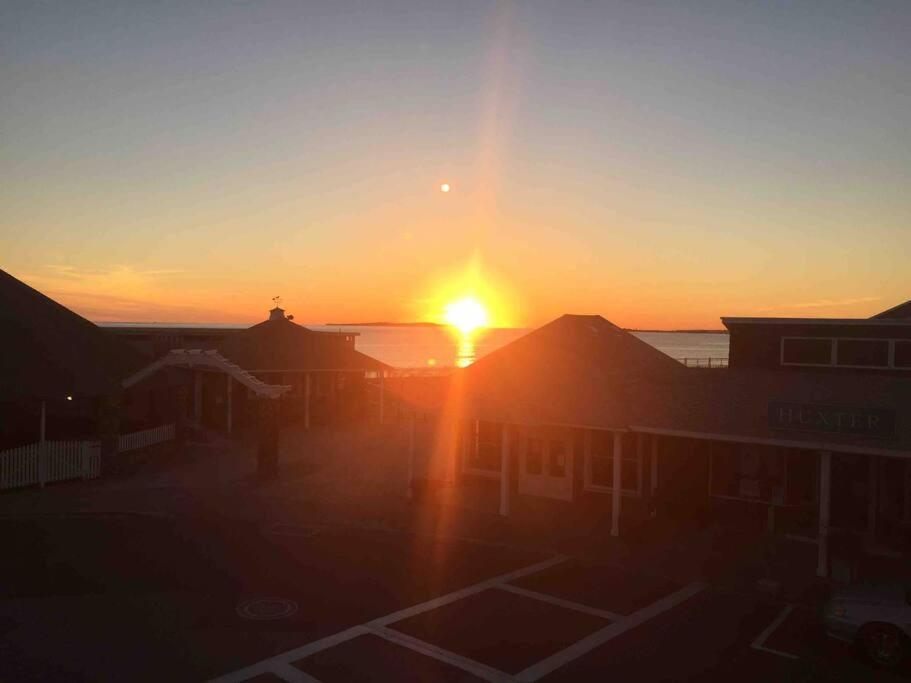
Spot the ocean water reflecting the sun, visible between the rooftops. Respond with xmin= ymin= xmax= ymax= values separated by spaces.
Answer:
xmin=307 ymin=325 xmax=728 ymax=368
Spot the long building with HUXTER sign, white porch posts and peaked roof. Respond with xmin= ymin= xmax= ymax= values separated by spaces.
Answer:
xmin=423 ymin=307 xmax=911 ymax=575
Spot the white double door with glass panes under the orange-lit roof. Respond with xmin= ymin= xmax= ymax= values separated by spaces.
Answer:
xmin=519 ymin=429 xmax=573 ymax=501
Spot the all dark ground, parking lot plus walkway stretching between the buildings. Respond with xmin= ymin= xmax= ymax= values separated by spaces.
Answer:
xmin=0 ymin=427 xmax=911 ymax=683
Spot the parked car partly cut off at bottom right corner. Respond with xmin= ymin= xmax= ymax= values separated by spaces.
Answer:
xmin=823 ymin=583 xmax=911 ymax=669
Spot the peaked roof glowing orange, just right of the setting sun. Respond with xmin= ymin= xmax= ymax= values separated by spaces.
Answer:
xmin=461 ymin=315 xmax=686 ymax=429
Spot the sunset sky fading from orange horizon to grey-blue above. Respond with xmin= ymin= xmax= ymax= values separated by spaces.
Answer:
xmin=0 ymin=0 xmax=911 ymax=328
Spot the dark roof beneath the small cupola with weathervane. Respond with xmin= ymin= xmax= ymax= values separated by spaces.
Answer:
xmin=219 ymin=317 xmax=389 ymax=372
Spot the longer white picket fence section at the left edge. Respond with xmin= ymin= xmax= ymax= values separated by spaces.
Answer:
xmin=0 ymin=441 xmax=101 ymax=490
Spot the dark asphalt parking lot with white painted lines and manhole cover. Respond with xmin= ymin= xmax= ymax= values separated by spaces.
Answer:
xmin=0 ymin=515 xmax=911 ymax=683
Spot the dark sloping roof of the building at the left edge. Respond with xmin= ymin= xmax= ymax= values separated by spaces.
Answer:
xmin=0 ymin=270 xmax=142 ymax=400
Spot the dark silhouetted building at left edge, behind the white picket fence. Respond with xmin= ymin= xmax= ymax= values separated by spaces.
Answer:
xmin=0 ymin=271 xmax=180 ymax=450
